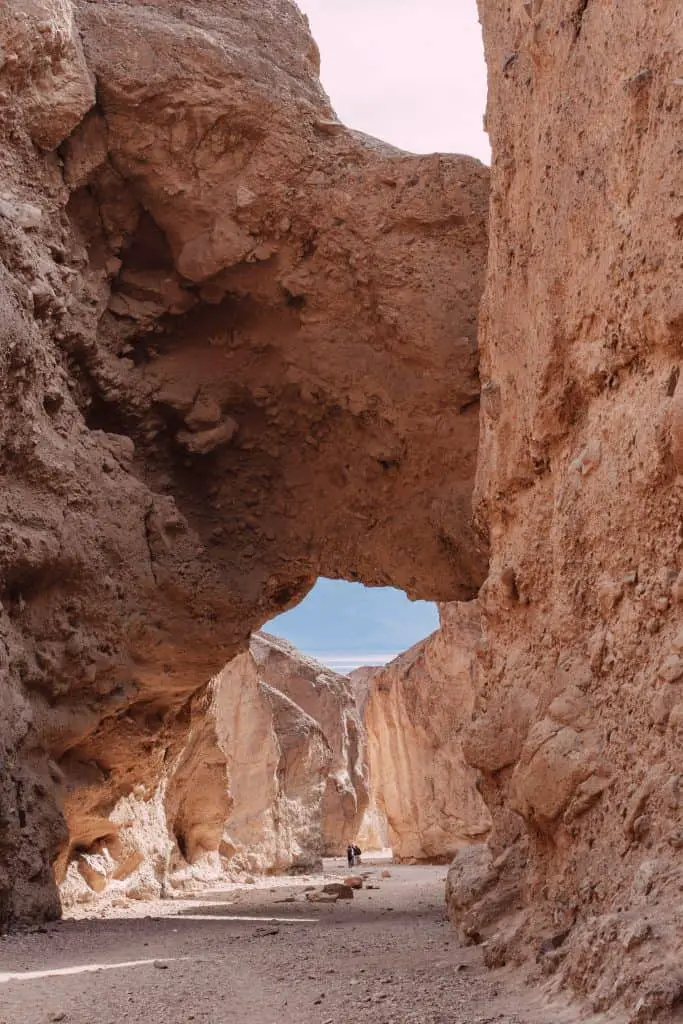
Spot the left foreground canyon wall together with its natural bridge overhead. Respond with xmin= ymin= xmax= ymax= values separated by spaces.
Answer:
xmin=0 ymin=0 xmax=487 ymax=929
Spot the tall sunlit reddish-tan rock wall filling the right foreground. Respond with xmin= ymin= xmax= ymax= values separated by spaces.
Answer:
xmin=444 ymin=0 xmax=683 ymax=1021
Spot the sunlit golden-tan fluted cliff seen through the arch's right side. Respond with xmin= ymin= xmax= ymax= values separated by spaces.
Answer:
xmin=365 ymin=602 xmax=490 ymax=861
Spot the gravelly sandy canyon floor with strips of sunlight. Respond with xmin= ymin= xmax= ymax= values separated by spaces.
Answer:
xmin=0 ymin=861 xmax=618 ymax=1024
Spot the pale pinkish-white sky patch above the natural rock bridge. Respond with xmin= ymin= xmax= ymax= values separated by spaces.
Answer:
xmin=297 ymin=0 xmax=490 ymax=163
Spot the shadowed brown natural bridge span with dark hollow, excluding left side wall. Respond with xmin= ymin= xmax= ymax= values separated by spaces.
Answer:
xmin=70 ymin=0 xmax=486 ymax=610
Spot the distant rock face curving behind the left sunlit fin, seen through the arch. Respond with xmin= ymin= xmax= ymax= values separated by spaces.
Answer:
xmin=250 ymin=633 xmax=368 ymax=856
